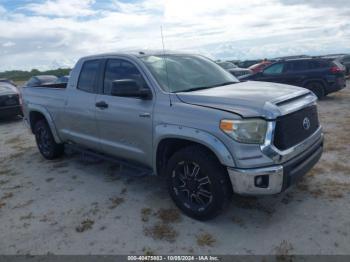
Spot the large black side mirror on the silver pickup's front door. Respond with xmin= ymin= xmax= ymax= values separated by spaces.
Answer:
xmin=111 ymin=79 xmax=152 ymax=99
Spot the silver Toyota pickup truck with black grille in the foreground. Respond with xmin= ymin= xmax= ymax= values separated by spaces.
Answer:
xmin=22 ymin=52 xmax=323 ymax=220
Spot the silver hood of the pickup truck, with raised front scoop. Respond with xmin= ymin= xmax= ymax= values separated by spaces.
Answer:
xmin=177 ymin=81 xmax=315 ymax=119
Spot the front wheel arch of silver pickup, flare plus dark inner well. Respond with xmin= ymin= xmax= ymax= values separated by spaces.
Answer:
xmin=153 ymin=125 xmax=235 ymax=175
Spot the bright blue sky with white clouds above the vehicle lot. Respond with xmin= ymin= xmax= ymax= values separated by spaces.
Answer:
xmin=0 ymin=0 xmax=350 ymax=71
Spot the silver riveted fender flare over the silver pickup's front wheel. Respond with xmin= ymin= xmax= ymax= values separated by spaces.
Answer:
xmin=153 ymin=124 xmax=235 ymax=171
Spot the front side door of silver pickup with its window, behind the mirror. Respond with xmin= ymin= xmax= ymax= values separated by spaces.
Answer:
xmin=96 ymin=59 xmax=154 ymax=166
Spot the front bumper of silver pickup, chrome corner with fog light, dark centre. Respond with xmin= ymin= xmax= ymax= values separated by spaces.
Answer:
xmin=228 ymin=135 xmax=323 ymax=195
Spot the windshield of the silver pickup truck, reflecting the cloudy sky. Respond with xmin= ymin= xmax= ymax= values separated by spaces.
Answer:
xmin=141 ymin=55 xmax=239 ymax=93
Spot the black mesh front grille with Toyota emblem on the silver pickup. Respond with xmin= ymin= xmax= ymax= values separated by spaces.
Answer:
xmin=274 ymin=105 xmax=319 ymax=150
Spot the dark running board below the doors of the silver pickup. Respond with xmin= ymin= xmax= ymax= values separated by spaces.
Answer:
xmin=65 ymin=143 xmax=154 ymax=177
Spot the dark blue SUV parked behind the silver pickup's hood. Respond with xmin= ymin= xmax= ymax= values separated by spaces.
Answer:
xmin=243 ymin=58 xmax=346 ymax=98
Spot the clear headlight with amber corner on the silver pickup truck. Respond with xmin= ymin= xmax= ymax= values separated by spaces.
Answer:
xmin=220 ymin=119 xmax=267 ymax=144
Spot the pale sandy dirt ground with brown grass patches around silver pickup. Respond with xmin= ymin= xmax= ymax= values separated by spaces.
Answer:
xmin=0 ymin=82 xmax=350 ymax=255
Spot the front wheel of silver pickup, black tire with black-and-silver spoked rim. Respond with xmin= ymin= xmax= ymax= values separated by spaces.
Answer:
xmin=166 ymin=145 xmax=232 ymax=221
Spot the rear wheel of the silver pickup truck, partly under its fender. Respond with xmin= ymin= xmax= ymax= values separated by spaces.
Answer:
xmin=34 ymin=120 xmax=64 ymax=160
